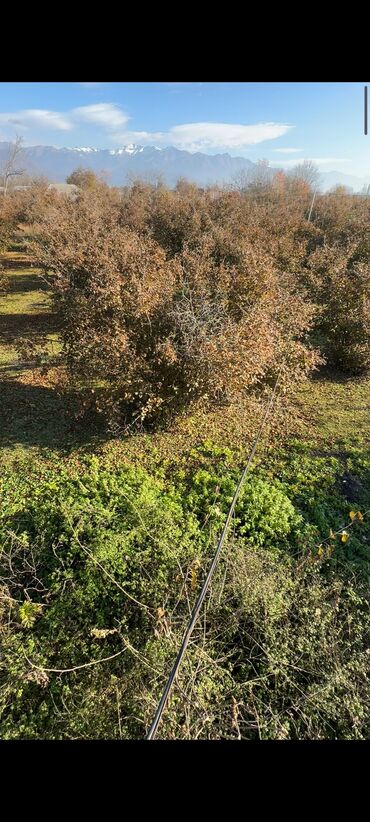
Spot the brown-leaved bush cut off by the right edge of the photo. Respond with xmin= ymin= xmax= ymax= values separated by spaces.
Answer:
xmin=305 ymin=193 xmax=370 ymax=374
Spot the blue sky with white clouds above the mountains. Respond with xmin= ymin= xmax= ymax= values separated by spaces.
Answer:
xmin=0 ymin=82 xmax=370 ymax=176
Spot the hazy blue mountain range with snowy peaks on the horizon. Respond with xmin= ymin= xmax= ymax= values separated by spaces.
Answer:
xmin=0 ymin=142 xmax=370 ymax=191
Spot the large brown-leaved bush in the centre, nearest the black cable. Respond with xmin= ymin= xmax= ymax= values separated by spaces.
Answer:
xmin=31 ymin=184 xmax=324 ymax=422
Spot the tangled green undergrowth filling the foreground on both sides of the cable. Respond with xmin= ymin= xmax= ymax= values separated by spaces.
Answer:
xmin=0 ymin=443 xmax=370 ymax=739
